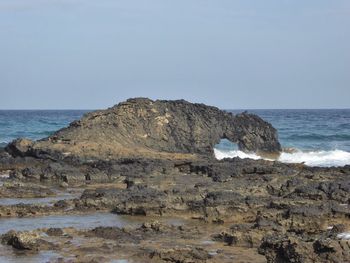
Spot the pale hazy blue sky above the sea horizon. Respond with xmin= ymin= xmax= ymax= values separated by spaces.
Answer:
xmin=0 ymin=0 xmax=350 ymax=109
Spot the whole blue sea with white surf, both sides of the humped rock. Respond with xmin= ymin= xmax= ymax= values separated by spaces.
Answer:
xmin=0 ymin=109 xmax=350 ymax=167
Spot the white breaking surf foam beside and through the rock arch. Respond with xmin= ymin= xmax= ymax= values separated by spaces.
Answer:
xmin=214 ymin=149 xmax=350 ymax=167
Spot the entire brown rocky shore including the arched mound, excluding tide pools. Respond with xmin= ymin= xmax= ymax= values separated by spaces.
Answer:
xmin=0 ymin=99 xmax=350 ymax=263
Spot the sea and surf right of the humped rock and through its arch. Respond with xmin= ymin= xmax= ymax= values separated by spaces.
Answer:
xmin=215 ymin=109 xmax=350 ymax=166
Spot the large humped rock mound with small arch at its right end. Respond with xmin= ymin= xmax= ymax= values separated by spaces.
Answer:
xmin=6 ymin=98 xmax=281 ymax=160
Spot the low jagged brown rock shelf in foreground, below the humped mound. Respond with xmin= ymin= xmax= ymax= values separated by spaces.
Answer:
xmin=0 ymin=154 xmax=350 ymax=263
